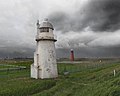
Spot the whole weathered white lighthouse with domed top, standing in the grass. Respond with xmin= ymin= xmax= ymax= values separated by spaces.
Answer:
xmin=31 ymin=19 xmax=58 ymax=79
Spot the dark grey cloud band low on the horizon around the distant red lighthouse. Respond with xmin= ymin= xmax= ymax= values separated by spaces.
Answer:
xmin=57 ymin=47 xmax=120 ymax=58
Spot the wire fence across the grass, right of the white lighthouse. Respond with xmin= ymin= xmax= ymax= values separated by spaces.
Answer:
xmin=58 ymin=61 xmax=120 ymax=75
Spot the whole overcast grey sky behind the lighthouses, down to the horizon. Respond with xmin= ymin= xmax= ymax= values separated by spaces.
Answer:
xmin=0 ymin=0 xmax=120 ymax=57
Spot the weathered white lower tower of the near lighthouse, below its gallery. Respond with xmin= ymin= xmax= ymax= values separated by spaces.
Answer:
xmin=31 ymin=40 xmax=58 ymax=79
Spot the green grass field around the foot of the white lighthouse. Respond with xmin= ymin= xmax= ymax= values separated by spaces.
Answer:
xmin=0 ymin=61 xmax=120 ymax=96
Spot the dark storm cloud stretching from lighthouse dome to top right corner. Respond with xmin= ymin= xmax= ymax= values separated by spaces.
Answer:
xmin=49 ymin=0 xmax=120 ymax=32
